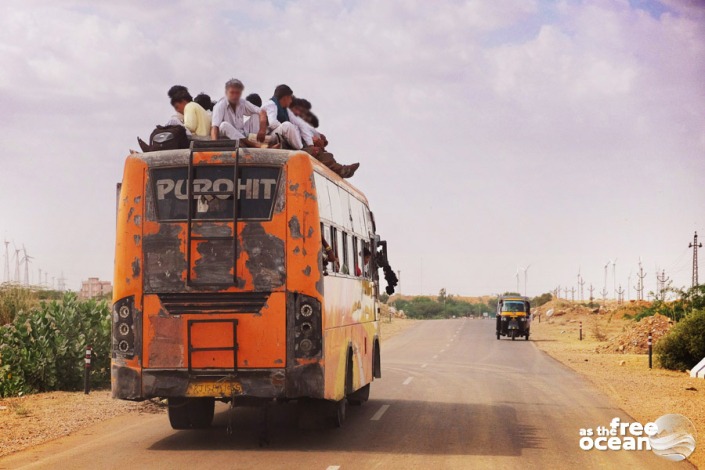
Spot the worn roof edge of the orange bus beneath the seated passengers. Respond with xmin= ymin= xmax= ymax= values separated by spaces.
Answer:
xmin=130 ymin=148 xmax=368 ymax=205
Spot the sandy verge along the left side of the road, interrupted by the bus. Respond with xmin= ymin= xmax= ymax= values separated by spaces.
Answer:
xmin=0 ymin=318 xmax=416 ymax=456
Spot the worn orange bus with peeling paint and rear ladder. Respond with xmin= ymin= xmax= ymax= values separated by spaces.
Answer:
xmin=111 ymin=140 xmax=394 ymax=429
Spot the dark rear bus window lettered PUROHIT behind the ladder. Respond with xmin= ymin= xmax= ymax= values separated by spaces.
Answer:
xmin=151 ymin=165 xmax=281 ymax=221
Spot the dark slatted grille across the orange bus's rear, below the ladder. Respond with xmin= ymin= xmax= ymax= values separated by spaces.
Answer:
xmin=159 ymin=292 xmax=270 ymax=315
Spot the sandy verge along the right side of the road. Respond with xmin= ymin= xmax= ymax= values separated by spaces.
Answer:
xmin=531 ymin=302 xmax=705 ymax=468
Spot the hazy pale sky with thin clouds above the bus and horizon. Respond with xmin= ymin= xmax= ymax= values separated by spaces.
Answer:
xmin=0 ymin=0 xmax=705 ymax=296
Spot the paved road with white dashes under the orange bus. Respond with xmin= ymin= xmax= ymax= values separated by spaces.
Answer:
xmin=0 ymin=319 xmax=689 ymax=470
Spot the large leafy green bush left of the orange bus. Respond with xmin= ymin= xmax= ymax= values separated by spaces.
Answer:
xmin=0 ymin=293 xmax=110 ymax=397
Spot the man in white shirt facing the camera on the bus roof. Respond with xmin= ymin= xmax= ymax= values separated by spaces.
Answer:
xmin=211 ymin=78 xmax=260 ymax=144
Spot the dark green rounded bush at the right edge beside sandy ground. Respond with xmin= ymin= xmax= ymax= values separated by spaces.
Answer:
xmin=656 ymin=310 xmax=705 ymax=371
